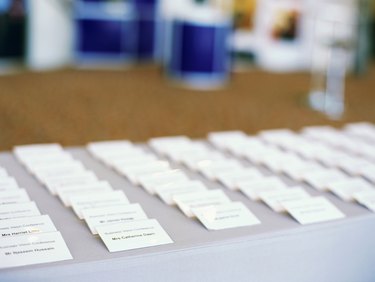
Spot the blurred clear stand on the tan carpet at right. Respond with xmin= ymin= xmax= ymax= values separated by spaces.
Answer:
xmin=308 ymin=2 xmax=357 ymax=120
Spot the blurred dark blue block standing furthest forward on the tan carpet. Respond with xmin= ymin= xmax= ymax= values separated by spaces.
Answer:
xmin=167 ymin=17 xmax=231 ymax=89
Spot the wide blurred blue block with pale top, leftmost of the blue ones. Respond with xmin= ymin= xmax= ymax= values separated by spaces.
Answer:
xmin=75 ymin=0 xmax=137 ymax=65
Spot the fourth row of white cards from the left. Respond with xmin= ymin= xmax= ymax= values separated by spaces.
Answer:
xmin=149 ymin=133 xmax=344 ymax=224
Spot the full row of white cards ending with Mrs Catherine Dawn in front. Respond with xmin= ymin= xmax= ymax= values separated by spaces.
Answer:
xmin=14 ymin=144 xmax=172 ymax=252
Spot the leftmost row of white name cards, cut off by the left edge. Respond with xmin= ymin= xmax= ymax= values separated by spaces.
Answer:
xmin=0 ymin=167 xmax=72 ymax=268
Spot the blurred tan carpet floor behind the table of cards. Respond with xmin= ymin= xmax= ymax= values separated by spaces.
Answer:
xmin=0 ymin=65 xmax=375 ymax=151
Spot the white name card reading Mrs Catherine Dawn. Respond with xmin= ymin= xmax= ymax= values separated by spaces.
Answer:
xmin=96 ymin=219 xmax=173 ymax=252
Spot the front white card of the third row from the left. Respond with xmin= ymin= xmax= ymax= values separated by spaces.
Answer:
xmin=191 ymin=202 xmax=260 ymax=230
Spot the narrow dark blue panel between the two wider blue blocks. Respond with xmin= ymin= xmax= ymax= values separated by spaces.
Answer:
xmin=133 ymin=0 xmax=160 ymax=60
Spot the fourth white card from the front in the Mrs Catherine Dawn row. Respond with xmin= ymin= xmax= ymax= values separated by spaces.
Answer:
xmin=56 ymin=181 xmax=112 ymax=207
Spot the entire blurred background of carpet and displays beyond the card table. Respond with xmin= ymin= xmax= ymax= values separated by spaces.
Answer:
xmin=0 ymin=0 xmax=375 ymax=150
